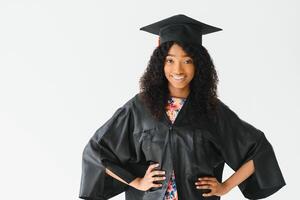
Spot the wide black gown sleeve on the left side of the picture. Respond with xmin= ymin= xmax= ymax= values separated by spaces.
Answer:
xmin=79 ymin=106 xmax=141 ymax=200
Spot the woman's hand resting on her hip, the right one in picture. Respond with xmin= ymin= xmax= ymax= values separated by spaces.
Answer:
xmin=195 ymin=177 xmax=230 ymax=197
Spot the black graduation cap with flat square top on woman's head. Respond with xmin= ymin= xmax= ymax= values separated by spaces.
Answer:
xmin=140 ymin=14 xmax=222 ymax=45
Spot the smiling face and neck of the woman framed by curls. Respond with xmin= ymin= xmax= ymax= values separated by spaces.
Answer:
xmin=164 ymin=43 xmax=195 ymax=96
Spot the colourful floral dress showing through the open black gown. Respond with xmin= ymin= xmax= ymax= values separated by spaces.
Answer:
xmin=164 ymin=96 xmax=186 ymax=200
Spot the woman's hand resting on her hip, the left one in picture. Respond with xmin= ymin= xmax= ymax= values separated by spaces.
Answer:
xmin=129 ymin=163 xmax=166 ymax=191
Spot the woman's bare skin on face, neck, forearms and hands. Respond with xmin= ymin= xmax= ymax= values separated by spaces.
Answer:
xmin=106 ymin=43 xmax=255 ymax=197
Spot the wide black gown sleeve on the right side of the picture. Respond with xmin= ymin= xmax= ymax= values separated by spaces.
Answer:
xmin=217 ymin=101 xmax=286 ymax=199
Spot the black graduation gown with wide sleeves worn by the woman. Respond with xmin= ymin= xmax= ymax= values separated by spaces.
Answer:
xmin=79 ymin=94 xmax=286 ymax=200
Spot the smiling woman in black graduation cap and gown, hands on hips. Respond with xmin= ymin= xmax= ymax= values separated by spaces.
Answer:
xmin=79 ymin=15 xmax=286 ymax=200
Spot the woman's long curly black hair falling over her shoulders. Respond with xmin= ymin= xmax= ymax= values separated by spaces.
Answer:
xmin=139 ymin=41 xmax=219 ymax=122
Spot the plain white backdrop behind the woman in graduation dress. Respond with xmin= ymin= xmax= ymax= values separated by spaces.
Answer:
xmin=0 ymin=0 xmax=300 ymax=200
